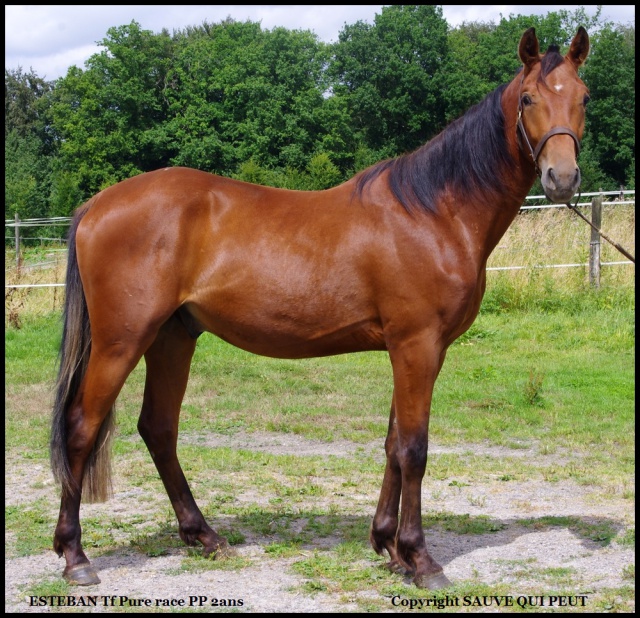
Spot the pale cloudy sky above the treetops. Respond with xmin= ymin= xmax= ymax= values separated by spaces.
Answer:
xmin=5 ymin=4 xmax=635 ymax=80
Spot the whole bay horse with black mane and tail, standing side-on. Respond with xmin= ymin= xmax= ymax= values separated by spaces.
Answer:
xmin=50 ymin=27 xmax=589 ymax=589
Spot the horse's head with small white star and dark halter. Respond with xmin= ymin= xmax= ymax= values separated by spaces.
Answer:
xmin=516 ymin=27 xmax=589 ymax=203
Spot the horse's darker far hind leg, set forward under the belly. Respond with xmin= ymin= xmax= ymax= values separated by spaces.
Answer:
xmin=138 ymin=314 xmax=228 ymax=556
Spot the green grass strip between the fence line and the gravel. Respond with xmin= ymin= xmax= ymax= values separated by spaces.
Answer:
xmin=5 ymin=305 xmax=634 ymax=478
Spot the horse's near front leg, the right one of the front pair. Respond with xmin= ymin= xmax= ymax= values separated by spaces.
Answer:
xmin=385 ymin=337 xmax=451 ymax=590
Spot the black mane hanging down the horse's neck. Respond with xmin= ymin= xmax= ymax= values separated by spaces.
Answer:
xmin=356 ymin=84 xmax=510 ymax=213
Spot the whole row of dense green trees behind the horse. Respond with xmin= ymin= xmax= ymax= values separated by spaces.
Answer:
xmin=5 ymin=5 xmax=635 ymax=229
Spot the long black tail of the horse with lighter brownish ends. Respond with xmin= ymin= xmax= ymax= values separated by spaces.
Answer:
xmin=50 ymin=203 xmax=115 ymax=502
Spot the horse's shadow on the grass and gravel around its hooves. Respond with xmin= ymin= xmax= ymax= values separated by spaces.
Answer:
xmin=90 ymin=507 xmax=624 ymax=570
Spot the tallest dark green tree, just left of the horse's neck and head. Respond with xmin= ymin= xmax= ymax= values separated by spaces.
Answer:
xmin=329 ymin=5 xmax=448 ymax=156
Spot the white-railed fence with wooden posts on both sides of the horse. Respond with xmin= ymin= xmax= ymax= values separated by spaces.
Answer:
xmin=4 ymin=190 xmax=636 ymax=288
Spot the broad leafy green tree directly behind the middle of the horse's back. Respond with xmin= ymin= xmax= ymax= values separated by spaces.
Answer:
xmin=170 ymin=20 xmax=344 ymax=174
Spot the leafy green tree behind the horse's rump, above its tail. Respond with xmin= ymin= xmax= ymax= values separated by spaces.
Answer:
xmin=52 ymin=22 xmax=174 ymax=196
